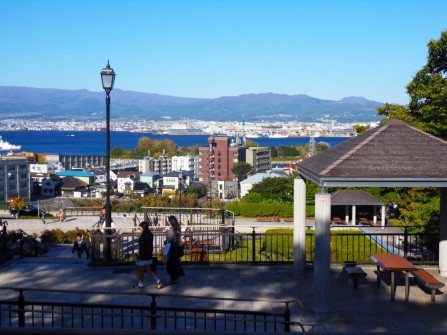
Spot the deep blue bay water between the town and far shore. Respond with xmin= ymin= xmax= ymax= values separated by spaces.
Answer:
xmin=0 ymin=131 xmax=349 ymax=155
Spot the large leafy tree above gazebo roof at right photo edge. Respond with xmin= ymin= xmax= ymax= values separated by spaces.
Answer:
xmin=377 ymin=30 xmax=447 ymax=139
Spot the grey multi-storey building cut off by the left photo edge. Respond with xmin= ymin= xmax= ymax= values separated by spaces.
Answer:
xmin=0 ymin=157 xmax=31 ymax=202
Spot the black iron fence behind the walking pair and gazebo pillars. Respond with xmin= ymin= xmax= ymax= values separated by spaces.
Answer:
xmin=91 ymin=225 xmax=439 ymax=265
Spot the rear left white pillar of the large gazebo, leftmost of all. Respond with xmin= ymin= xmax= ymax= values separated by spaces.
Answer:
xmin=293 ymin=178 xmax=306 ymax=276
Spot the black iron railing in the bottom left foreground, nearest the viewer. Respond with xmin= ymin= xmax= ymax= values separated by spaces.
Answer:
xmin=0 ymin=288 xmax=304 ymax=333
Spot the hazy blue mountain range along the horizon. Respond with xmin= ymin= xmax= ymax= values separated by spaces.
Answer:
xmin=0 ymin=86 xmax=384 ymax=122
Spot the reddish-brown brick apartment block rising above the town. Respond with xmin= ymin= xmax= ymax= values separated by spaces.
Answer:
xmin=199 ymin=136 xmax=247 ymax=184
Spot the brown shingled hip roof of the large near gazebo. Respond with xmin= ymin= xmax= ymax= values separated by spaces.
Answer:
xmin=298 ymin=119 xmax=447 ymax=187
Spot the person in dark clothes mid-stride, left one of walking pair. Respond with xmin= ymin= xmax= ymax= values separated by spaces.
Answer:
xmin=134 ymin=221 xmax=163 ymax=289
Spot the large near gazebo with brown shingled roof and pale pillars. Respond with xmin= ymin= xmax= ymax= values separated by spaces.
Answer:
xmin=294 ymin=119 xmax=447 ymax=317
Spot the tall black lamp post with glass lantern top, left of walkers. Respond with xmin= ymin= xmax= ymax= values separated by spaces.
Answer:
xmin=101 ymin=61 xmax=115 ymax=261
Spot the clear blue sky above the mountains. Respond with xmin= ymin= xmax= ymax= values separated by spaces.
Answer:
xmin=0 ymin=0 xmax=447 ymax=104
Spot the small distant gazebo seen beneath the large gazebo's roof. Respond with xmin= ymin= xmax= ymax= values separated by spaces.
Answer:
xmin=331 ymin=190 xmax=385 ymax=227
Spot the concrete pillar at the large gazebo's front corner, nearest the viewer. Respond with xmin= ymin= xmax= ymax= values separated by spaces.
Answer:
xmin=314 ymin=193 xmax=331 ymax=319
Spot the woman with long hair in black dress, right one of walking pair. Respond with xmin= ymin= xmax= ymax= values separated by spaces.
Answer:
xmin=166 ymin=215 xmax=185 ymax=285
